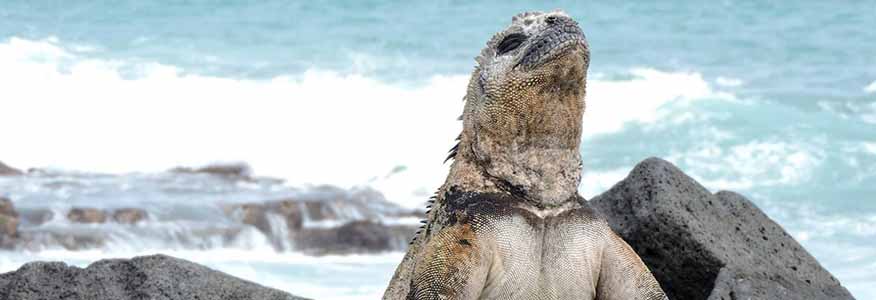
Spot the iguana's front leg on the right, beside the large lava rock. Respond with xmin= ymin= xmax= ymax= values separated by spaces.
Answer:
xmin=596 ymin=231 xmax=669 ymax=300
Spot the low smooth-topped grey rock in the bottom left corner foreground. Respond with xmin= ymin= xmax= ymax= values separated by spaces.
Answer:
xmin=0 ymin=255 xmax=303 ymax=300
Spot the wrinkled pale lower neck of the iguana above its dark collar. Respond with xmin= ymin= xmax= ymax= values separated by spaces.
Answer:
xmin=444 ymin=133 xmax=581 ymax=208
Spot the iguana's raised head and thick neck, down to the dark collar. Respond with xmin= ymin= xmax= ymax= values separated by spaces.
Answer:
xmin=451 ymin=11 xmax=590 ymax=206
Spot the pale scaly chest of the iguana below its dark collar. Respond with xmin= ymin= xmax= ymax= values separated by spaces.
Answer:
xmin=476 ymin=207 xmax=601 ymax=299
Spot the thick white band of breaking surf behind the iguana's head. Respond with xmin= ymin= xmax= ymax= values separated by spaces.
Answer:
xmin=0 ymin=38 xmax=730 ymax=206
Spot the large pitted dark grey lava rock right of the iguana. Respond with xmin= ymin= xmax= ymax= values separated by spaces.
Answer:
xmin=590 ymin=158 xmax=854 ymax=300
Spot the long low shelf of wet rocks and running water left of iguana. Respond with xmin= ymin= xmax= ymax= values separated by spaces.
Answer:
xmin=0 ymin=182 xmax=423 ymax=254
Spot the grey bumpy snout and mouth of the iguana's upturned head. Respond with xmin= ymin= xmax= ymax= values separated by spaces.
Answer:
xmin=517 ymin=16 xmax=587 ymax=69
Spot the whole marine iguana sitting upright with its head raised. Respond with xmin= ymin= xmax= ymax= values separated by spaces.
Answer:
xmin=383 ymin=11 xmax=667 ymax=299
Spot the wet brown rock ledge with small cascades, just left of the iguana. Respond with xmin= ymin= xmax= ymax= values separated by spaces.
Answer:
xmin=225 ymin=187 xmax=423 ymax=255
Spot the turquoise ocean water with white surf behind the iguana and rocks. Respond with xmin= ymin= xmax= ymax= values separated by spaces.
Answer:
xmin=0 ymin=0 xmax=876 ymax=299
